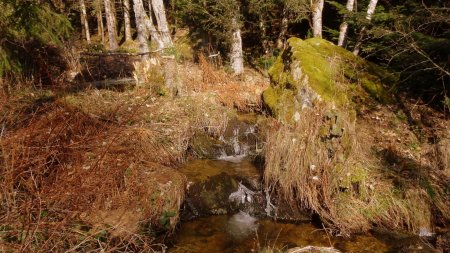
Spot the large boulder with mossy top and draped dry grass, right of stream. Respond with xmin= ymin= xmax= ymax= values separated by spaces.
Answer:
xmin=263 ymin=38 xmax=450 ymax=235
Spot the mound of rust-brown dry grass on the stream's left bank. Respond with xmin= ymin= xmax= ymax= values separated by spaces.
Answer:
xmin=0 ymin=101 xmax=185 ymax=252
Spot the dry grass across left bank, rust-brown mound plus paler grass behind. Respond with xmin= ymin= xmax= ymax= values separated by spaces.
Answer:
xmin=0 ymin=83 xmax=239 ymax=252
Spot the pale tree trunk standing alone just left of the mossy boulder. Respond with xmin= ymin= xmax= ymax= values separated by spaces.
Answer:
xmin=230 ymin=18 xmax=244 ymax=74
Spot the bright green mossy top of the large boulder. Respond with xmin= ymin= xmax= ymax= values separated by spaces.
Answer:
xmin=263 ymin=38 xmax=395 ymax=122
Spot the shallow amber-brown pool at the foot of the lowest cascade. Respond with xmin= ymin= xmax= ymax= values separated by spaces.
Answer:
xmin=168 ymin=214 xmax=392 ymax=253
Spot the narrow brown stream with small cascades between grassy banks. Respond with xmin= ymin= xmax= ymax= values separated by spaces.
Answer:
xmin=167 ymin=115 xmax=434 ymax=253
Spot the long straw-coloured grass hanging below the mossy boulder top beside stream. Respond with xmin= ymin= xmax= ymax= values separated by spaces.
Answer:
xmin=264 ymin=104 xmax=432 ymax=235
